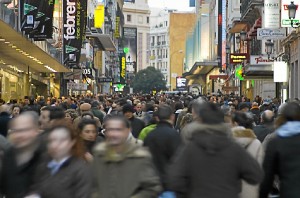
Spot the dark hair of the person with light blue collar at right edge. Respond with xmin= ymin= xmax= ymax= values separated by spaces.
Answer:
xmin=276 ymin=102 xmax=300 ymax=127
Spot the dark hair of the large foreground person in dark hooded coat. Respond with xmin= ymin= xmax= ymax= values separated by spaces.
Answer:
xmin=193 ymin=102 xmax=224 ymax=124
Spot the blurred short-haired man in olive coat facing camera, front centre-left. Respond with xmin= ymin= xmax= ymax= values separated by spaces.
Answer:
xmin=92 ymin=115 xmax=161 ymax=198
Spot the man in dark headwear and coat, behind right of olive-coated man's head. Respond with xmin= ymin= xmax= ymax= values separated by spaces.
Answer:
xmin=123 ymin=104 xmax=145 ymax=138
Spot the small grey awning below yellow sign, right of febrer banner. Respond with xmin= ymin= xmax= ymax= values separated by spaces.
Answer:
xmin=86 ymin=33 xmax=116 ymax=52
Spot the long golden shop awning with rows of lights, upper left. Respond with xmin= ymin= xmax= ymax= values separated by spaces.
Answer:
xmin=0 ymin=20 xmax=69 ymax=72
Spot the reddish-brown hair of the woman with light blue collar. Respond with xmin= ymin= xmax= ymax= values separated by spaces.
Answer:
xmin=49 ymin=120 xmax=85 ymax=158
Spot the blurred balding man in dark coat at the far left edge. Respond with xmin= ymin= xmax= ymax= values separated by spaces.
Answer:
xmin=0 ymin=112 xmax=42 ymax=198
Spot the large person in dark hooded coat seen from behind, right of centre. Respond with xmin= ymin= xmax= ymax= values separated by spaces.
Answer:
xmin=168 ymin=103 xmax=263 ymax=198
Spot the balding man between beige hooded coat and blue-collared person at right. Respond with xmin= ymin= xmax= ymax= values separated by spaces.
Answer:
xmin=253 ymin=110 xmax=275 ymax=142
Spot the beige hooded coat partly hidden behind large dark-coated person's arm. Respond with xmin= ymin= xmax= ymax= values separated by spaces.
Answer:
xmin=232 ymin=127 xmax=264 ymax=198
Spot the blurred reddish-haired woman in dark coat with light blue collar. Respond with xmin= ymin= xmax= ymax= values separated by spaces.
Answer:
xmin=27 ymin=123 xmax=91 ymax=198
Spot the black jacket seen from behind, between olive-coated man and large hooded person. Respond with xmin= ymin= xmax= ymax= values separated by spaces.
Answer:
xmin=144 ymin=121 xmax=181 ymax=188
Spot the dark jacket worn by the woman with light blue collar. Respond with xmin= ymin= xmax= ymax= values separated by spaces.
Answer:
xmin=31 ymin=157 xmax=92 ymax=198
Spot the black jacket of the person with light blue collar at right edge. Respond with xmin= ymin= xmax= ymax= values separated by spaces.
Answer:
xmin=260 ymin=134 xmax=300 ymax=198
